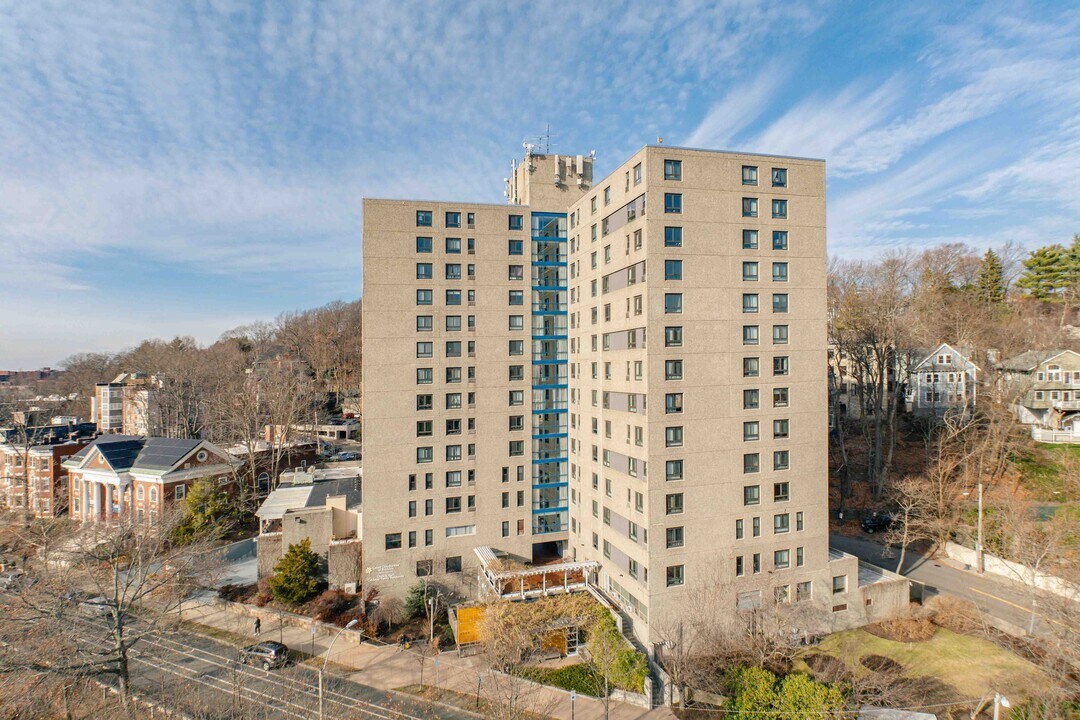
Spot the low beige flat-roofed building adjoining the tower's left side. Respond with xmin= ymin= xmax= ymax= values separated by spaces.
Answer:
xmin=255 ymin=466 xmax=363 ymax=593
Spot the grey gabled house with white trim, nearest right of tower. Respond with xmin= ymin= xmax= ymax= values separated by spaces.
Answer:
xmin=905 ymin=342 xmax=982 ymax=416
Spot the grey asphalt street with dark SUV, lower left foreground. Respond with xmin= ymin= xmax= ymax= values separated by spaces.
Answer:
xmin=80 ymin=620 xmax=475 ymax=720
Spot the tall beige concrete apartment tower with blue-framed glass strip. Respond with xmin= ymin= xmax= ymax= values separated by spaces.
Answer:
xmin=363 ymin=146 xmax=906 ymax=642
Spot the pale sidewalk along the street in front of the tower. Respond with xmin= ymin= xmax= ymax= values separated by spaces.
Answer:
xmin=174 ymin=601 xmax=675 ymax=720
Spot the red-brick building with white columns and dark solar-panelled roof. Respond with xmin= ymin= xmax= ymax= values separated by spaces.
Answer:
xmin=64 ymin=435 xmax=239 ymax=524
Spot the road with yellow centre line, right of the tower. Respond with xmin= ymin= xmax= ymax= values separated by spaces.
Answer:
xmin=829 ymin=534 xmax=1080 ymax=634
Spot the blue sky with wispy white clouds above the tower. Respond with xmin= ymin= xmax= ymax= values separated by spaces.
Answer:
xmin=0 ymin=0 xmax=1080 ymax=368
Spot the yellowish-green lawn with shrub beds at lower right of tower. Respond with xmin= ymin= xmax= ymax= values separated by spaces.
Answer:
xmin=795 ymin=628 xmax=1047 ymax=698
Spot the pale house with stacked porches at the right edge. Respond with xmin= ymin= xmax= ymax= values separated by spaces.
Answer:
xmin=998 ymin=350 xmax=1080 ymax=443
